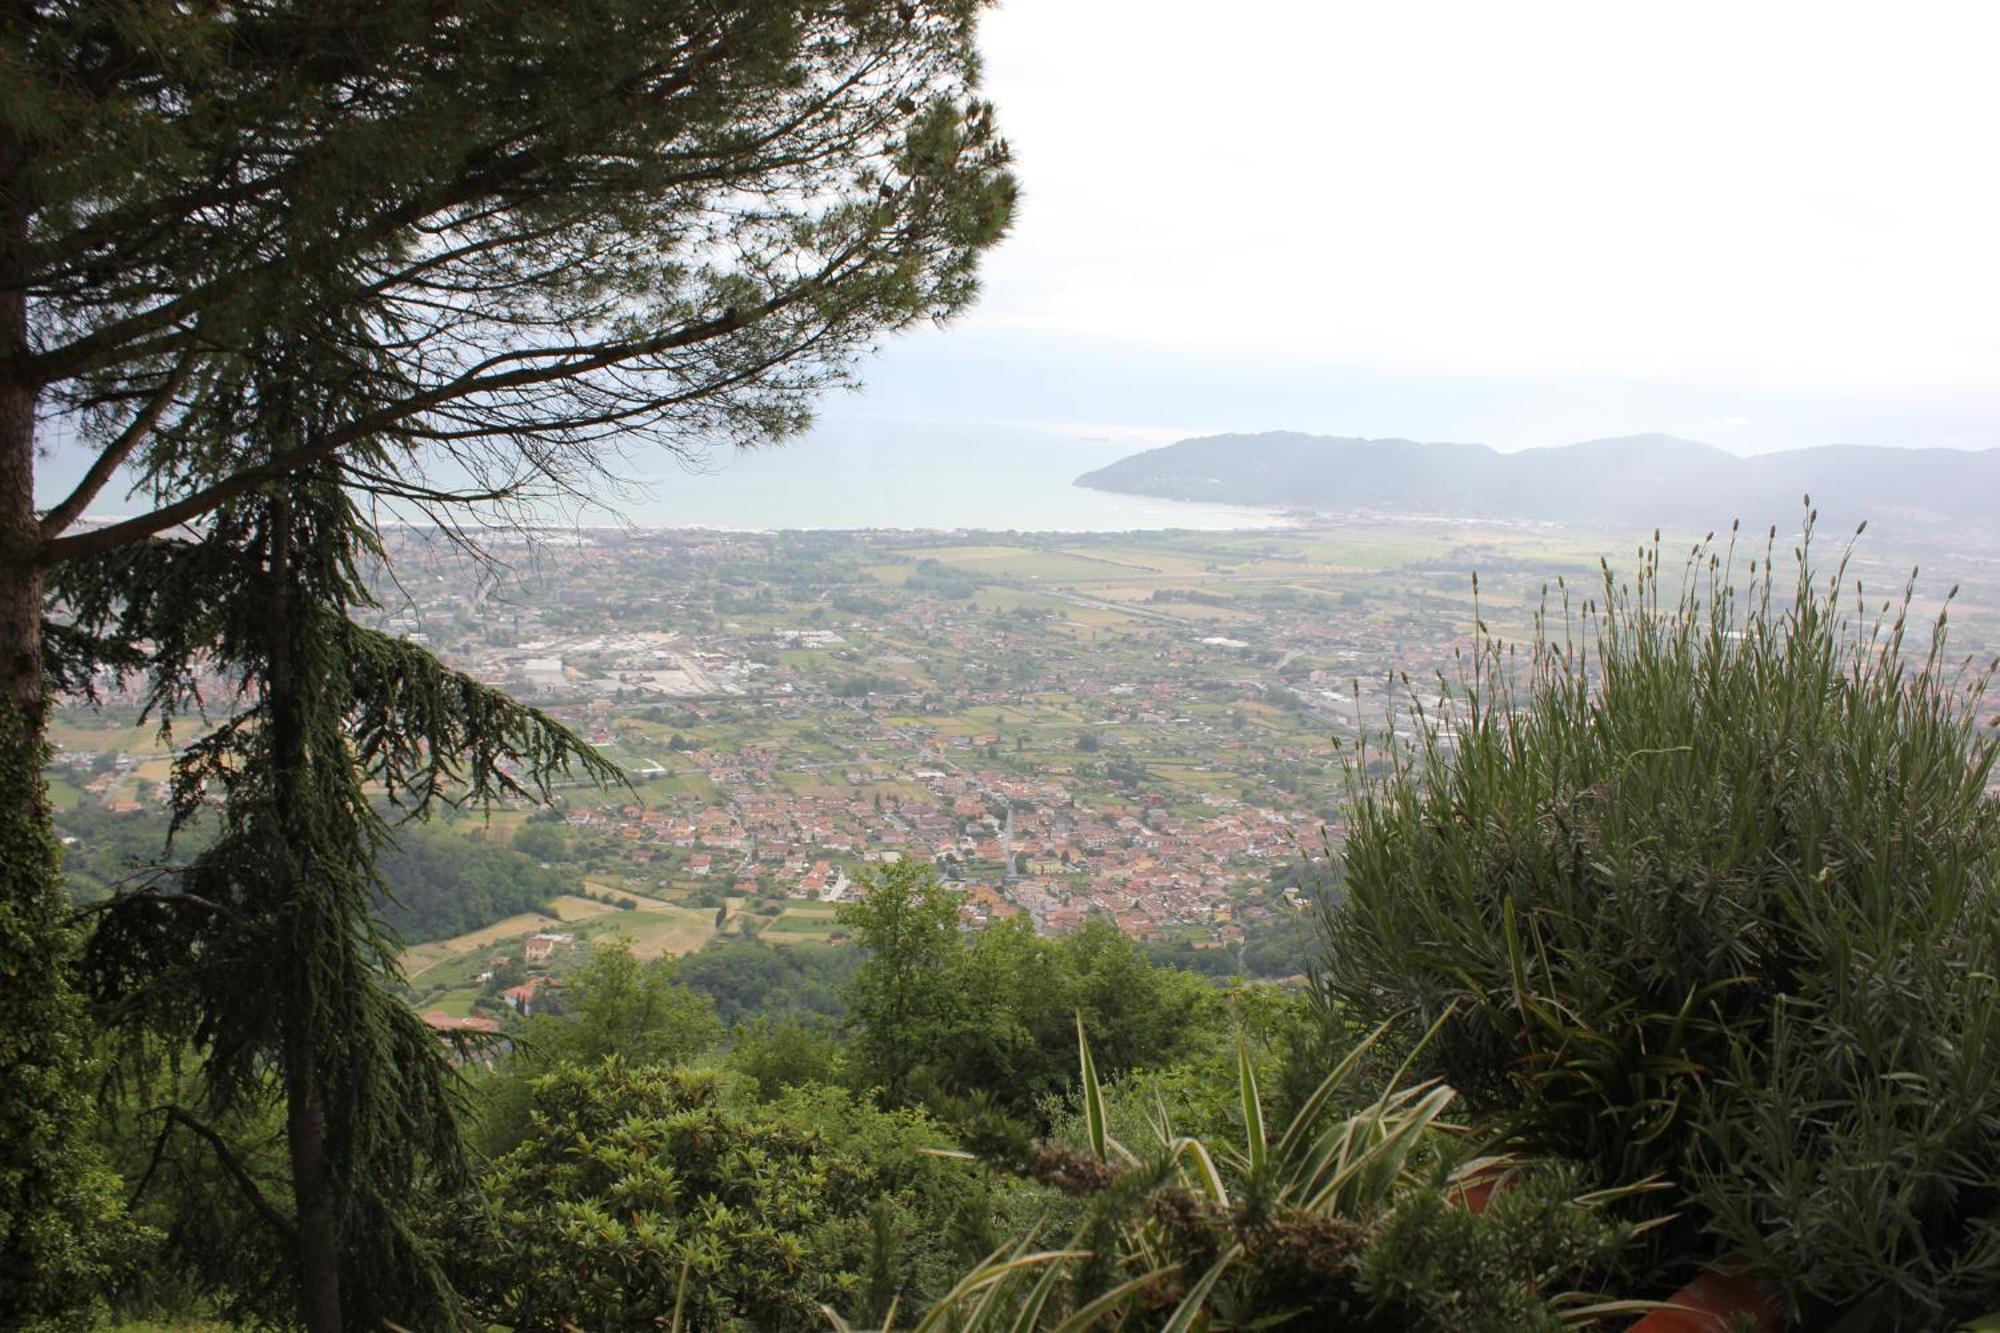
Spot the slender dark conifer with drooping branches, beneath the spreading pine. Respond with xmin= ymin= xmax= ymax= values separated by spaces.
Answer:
xmin=60 ymin=454 xmax=610 ymax=1333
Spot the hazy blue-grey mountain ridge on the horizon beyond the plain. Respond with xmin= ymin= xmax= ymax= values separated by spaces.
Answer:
xmin=1076 ymin=430 xmax=2000 ymax=536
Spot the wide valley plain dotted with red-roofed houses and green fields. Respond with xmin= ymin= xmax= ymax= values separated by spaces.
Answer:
xmin=52 ymin=516 xmax=2000 ymax=1023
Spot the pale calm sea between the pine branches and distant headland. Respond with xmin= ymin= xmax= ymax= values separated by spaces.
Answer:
xmin=604 ymin=418 xmax=1284 ymax=532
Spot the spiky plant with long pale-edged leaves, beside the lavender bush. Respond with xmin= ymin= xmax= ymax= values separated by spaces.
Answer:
xmin=868 ymin=1023 xmax=1632 ymax=1333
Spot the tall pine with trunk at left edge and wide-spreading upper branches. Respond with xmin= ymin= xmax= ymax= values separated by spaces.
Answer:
xmin=0 ymin=0 xmax=1012 ymax=1304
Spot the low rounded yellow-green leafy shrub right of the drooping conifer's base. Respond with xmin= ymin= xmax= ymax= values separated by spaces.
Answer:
xmin=458 ymin=1059 xmax=984 ymax=1331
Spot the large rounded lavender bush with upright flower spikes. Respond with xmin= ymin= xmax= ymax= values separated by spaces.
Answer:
xmin=1322 ymin=522 xmax=2000 ymax=1327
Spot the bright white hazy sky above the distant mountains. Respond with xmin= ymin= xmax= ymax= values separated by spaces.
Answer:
xmin=834 ymin=0 xmax=2000 ymax=450
